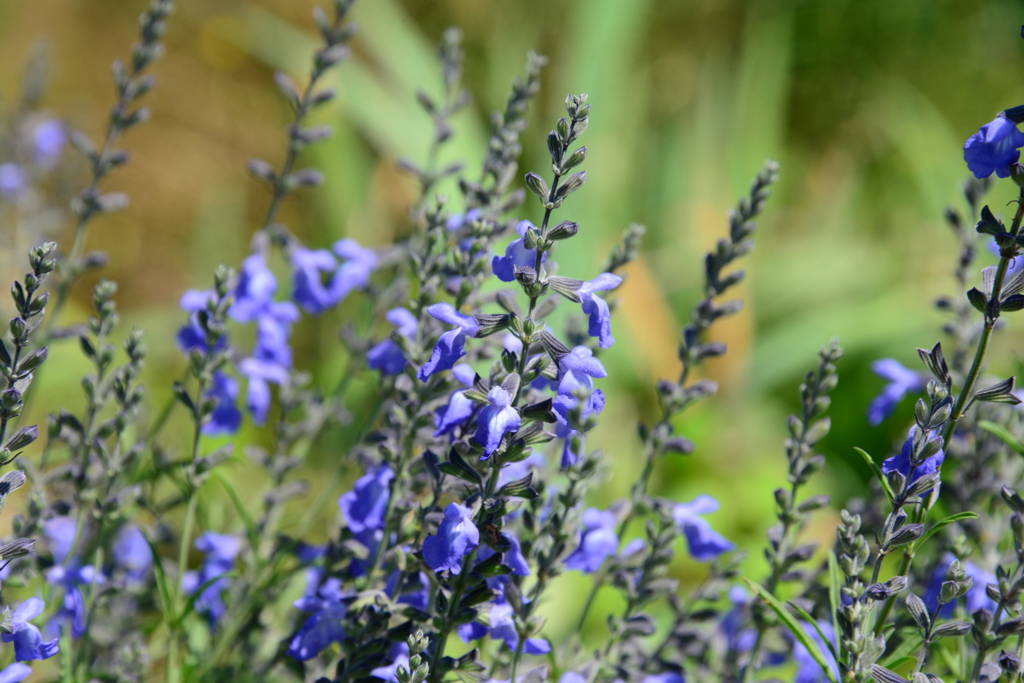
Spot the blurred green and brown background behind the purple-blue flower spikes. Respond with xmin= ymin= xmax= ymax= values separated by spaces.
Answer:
xmin=0 ymin=0 xmax=1024 ymax=647
